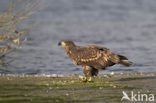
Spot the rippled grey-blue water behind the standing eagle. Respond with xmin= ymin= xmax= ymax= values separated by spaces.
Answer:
xmin=0 ymin=0 xmax=156 ymax=74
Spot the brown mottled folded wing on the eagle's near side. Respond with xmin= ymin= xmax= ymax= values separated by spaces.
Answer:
xmin=72 ymin=45 xmax=117 ymax=66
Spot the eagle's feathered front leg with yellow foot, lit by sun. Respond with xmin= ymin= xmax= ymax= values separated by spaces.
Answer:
xmin=83 ymin=66 xmax=93 ymax=82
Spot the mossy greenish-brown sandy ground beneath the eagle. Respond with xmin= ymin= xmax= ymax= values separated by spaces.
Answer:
xmin=0 ymin=74 xmax=156 ymax=103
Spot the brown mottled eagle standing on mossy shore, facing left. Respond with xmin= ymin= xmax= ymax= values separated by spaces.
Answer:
xmin=58 ymin=40 xmax=132 ymax=82
